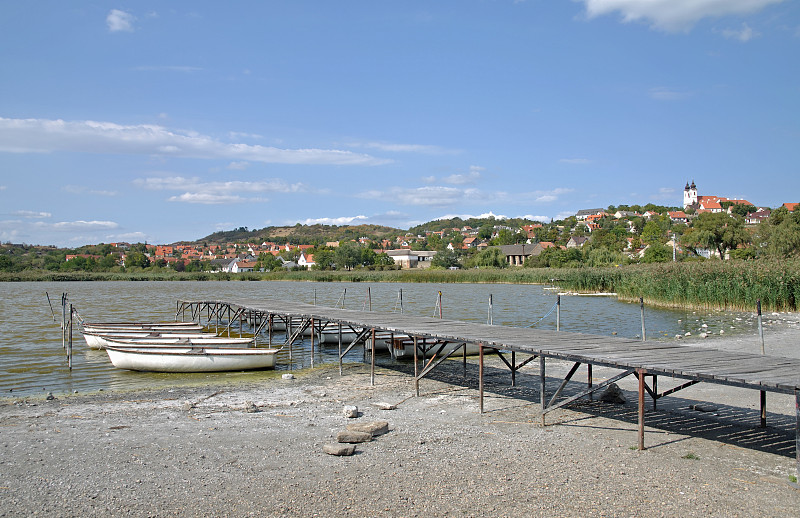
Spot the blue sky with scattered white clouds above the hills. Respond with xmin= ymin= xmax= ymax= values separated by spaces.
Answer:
xmin=0 ymin=0 xmax=800 ymax=247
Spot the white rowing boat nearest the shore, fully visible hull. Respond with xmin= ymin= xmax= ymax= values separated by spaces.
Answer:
xmin=106 ymin=346 xmax=278 ymax=372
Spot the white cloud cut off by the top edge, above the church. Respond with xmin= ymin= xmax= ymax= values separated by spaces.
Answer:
xmin=581 ymin=0 xmax=783 ymax=32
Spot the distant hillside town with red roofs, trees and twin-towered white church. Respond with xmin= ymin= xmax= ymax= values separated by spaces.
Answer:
xmin=0 ymin=181 xmax=800 ymax=274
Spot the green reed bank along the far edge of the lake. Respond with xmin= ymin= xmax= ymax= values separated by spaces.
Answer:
xmin=0 ymin=259 xmax=800 ymax=311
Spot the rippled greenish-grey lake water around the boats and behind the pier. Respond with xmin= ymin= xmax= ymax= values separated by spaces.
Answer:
xmin=0 ymin=281 xmax=757 ymax=398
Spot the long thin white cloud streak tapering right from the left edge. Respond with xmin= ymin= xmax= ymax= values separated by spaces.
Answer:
xmin=0 ymin=117 xmax=391 ymax=165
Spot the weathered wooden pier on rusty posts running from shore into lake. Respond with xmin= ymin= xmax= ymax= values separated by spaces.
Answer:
xmin=176 ymin=299 xmax=800 ymax=486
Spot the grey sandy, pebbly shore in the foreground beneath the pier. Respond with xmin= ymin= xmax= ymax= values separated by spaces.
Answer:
xmin=0 ymin=323 xmax=800 ymax=517
